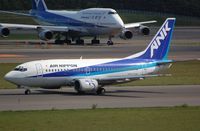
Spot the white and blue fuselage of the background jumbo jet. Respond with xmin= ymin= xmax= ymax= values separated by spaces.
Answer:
xmin=31 ymin=8 xmax=124 ymax=36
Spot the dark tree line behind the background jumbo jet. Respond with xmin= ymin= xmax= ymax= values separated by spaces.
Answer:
xmin=0 ymin=0 xmax=200 ymax=17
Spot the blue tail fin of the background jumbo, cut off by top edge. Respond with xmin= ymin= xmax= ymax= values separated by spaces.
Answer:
xmin=32 ymin=0 xmax=47 ymax=11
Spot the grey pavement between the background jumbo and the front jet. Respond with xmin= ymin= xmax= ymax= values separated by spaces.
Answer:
xmin=0 ymin=27 xmax=200 ymax=63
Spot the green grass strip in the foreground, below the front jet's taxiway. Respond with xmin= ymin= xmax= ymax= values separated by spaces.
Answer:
xmin=0 ymin=107 xmax=200 ymax=131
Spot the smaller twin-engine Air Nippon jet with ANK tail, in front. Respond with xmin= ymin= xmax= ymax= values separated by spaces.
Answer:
xmin=5 ymin=18 xmax=175 ymax=94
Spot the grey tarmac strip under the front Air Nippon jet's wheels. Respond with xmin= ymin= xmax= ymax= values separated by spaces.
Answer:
xmin=0 ymin=85 xmax=200 ymax=111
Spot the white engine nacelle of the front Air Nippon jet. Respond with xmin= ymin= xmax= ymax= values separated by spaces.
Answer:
xmin=75 ymin=79 xmax=99 ymax=92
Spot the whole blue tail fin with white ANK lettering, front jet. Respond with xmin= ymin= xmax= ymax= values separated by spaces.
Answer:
xmin=128 ymin=18 xmax=176 ymax=59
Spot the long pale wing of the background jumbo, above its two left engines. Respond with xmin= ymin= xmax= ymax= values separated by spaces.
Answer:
xmin=0 ymin=23 xmax=69 ymax=32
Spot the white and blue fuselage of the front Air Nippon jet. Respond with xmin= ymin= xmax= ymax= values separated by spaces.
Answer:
xmin=3 ymin=59 xmax=169 ymax=88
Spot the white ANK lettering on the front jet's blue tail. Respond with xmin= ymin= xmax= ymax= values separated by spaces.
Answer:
xmin=151 ymin=22 xmax=171 ymax=58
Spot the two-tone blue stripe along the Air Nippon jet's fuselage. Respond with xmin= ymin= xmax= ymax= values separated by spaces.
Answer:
xmin=29 ymin=59 xmax=170 ymax=77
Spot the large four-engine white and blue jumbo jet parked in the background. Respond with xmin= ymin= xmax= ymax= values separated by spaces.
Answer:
xmin=0 ymin=0 xmax=156 ymax=45
